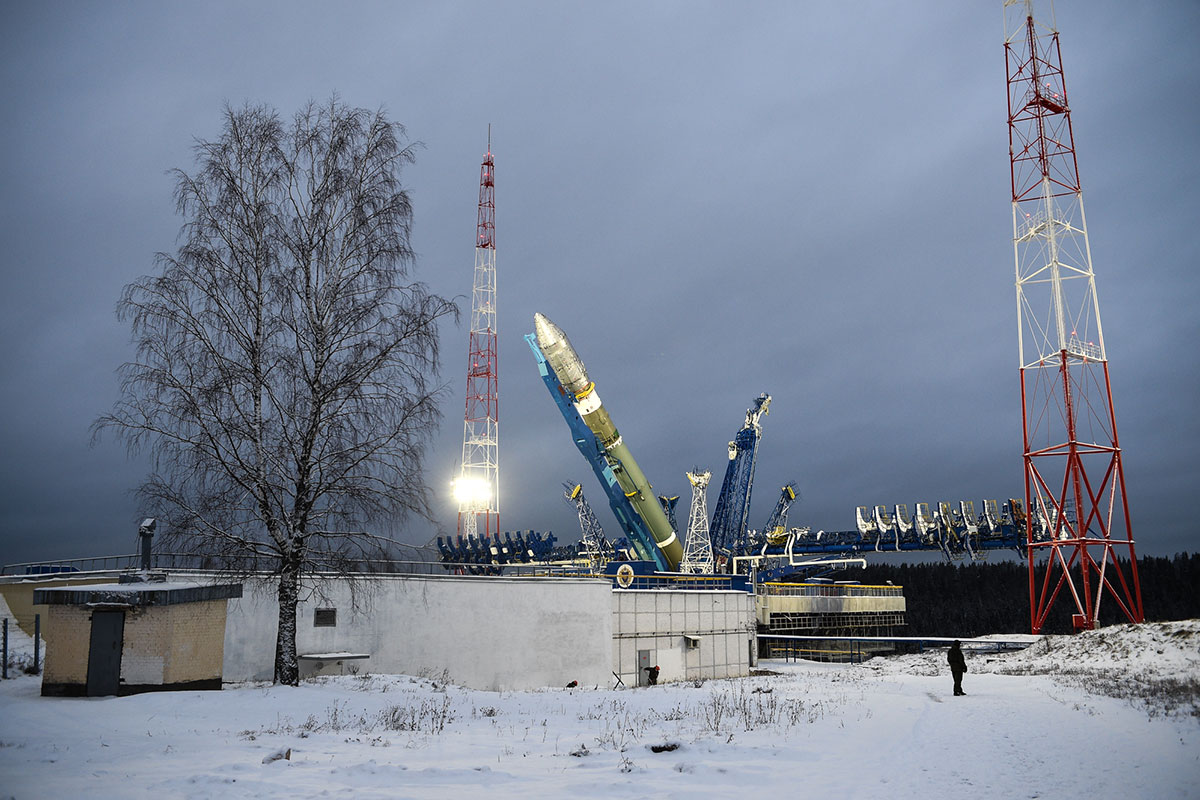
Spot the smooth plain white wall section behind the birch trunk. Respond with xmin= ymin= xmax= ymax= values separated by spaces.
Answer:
xmin=224 ymin=576 xmax=613 ymax=691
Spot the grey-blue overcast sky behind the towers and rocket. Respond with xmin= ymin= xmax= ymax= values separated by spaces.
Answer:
xmin=0 ymin=0 xmax=1200 ymax=563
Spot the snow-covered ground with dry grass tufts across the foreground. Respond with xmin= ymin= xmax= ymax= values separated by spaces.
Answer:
xmin=0 ymin=621 xmax=1200 ymax=800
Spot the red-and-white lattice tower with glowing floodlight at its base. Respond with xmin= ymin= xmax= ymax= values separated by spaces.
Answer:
xmin=454 ymin=133 xmax=500 ymax=536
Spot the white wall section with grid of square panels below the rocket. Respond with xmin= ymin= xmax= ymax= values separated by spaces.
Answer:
xmin=612 ymin=589 xmax=756 ymax=686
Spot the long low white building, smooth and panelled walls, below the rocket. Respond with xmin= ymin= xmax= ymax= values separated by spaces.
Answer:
xmin=224 ymin=575 xmax=755 ymax=691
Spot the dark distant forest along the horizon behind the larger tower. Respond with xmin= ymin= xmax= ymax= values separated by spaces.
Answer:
xmin=834 ymin=553 xmax=1200 ymax=637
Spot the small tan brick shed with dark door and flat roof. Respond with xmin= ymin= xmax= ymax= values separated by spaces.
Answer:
xmin=34 ymin=581 xmax=241 ymax=697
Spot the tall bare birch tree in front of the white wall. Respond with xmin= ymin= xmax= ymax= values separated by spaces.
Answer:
xmin=95 ymin=97 xmax=457 ymax=685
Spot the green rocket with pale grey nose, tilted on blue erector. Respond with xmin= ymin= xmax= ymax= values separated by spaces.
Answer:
xmin=533 ymin=314 xmax=683 ymax=570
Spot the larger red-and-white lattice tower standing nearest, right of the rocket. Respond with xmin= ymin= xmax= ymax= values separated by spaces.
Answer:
xmin=1004 ymin=0 xmax=1142 ymax=633
